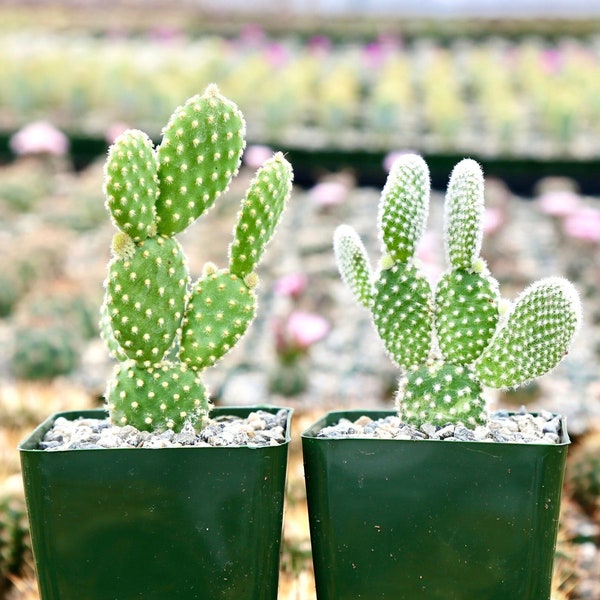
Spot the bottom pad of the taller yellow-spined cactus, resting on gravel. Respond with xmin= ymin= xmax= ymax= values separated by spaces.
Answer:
xmin=106 ymin=361 xmax=210 ymax=432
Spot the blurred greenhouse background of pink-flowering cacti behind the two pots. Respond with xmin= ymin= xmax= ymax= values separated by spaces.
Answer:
xmin=0 ymin=0 xmax=600 ymax=600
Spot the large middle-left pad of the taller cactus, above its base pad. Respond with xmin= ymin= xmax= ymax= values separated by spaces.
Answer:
xmin=105 ymin=236 xmax=189 ymax=365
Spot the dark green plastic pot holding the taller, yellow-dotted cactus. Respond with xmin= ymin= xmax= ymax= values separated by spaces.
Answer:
xmin=19 ymin=407 xmax=292 ymax=600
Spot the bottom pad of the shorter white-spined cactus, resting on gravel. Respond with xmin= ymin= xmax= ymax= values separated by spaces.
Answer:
xmin=398 ymin=362 xmax=487 ymax=427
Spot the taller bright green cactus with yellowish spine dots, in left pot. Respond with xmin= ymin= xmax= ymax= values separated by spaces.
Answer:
xmin=100 ymin=84 xmax=293 ymax=431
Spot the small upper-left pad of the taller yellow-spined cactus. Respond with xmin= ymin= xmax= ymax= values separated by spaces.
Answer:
xmin=104 ymin=129 xmax=158 ymax=242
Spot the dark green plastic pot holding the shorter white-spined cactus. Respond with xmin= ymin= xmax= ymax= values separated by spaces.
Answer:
xmin=302 ymin=411 xmax=569 ymax=600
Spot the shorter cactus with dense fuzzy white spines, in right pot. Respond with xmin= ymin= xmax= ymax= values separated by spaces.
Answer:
xmin=334 ymin=154 xmax=581 ymax=428
